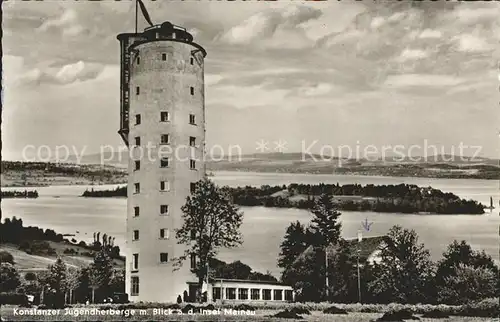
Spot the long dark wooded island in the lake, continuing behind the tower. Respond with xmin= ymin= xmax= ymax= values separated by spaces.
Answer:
xmin=82 ymin=183 xmax=485 ymax=214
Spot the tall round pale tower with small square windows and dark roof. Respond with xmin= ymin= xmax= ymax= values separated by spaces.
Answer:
xmin=118 ymin=22 xmax=206 ymax=302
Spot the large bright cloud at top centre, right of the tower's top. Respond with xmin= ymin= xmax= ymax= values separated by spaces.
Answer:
xmin=217 ymin=6 xmax=321 ymax=48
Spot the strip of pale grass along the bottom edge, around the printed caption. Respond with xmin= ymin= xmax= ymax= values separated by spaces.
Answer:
xmin=0 ymin=306 xmax=492 ymax=322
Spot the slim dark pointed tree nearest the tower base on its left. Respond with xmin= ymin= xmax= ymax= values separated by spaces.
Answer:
xmin=89 ymin=249 xmax=113 ymax=303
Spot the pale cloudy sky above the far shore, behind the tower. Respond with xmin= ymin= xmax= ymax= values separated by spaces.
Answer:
xmin=2 ymin=1 xmax=500 ymax=160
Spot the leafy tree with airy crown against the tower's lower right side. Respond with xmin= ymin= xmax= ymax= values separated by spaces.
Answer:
xmin=174 ymin=179 xmax=243 ymax=302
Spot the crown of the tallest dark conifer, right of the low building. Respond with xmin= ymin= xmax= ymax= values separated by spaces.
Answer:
xmin=311 ymin=193 xmax=342 ymax=248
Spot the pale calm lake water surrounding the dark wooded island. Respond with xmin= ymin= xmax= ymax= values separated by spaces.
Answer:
xmin=2 ymin=172 xmax=500 ymax=277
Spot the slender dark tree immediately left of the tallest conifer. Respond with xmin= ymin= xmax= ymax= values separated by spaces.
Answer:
xmin=278 ymin=221 xmax=308 ymax=283
